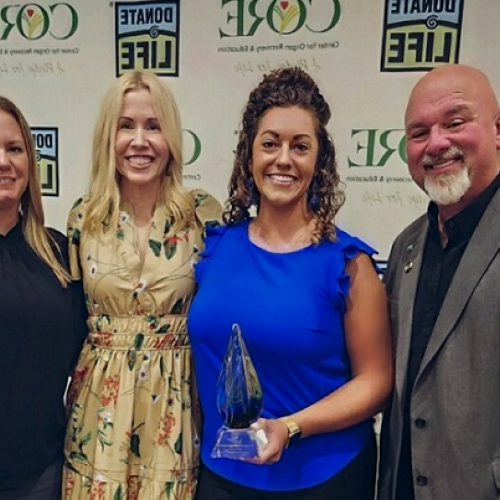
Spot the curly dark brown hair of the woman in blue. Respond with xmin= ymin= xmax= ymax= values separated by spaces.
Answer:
xmin=223 ymin=68 xmax=345 ymax=245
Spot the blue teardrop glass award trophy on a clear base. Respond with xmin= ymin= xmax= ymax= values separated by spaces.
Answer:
xmin=212 ymin=324 xmax=267 ymax=459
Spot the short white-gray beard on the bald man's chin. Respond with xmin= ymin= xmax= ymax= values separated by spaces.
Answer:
xmin=424 ymin=165 xmax=471 ymax=206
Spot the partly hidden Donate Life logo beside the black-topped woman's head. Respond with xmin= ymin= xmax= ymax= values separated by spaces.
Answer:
xmin=31 ymin=127 xmax=59 ymax=196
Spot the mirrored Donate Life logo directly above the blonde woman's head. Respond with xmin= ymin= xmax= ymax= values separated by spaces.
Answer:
xmin=115 ymin=0 xmax=179 ymax=76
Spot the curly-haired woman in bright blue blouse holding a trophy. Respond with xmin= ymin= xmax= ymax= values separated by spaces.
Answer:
xmin=188 ymin=68 xmax=392 ymax=500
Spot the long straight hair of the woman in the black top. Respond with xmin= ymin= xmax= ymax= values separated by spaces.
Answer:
xmin=0 ymin=96 xmax=70 ymax=288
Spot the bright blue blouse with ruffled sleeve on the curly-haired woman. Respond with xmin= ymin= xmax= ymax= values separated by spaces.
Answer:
xmin=188 ymin=221 xmax=375 ymax=491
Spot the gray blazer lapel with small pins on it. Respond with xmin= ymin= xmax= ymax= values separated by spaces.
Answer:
xmin=395 ymin=221 xmax=428 ymax=401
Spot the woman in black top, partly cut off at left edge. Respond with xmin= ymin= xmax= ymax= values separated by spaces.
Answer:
xmin=0 ymin=97 xmax=86 ymax=500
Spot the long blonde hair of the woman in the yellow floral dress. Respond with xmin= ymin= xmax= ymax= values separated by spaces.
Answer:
xmin=83 ymin=71 xmax=194 ymax=232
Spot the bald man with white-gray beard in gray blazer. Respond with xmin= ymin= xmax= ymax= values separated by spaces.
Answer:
xmin=378 ymin=65 xmax=500 ymax=500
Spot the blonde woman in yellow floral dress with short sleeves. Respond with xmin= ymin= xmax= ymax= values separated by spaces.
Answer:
xmin=63 ymin=71 xmax=220 ymax=500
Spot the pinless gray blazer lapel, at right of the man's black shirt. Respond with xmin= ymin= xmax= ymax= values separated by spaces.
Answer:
xmin=415 ymin=190 xmax=500 ymax=387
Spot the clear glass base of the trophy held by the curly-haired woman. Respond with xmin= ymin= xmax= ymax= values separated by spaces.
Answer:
xmin=211 ymin=426 xmax=267 ymax=460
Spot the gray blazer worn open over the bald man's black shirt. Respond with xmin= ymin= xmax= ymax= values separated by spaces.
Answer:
xmin=378 ymin=190 xmax=500 ymax=500
